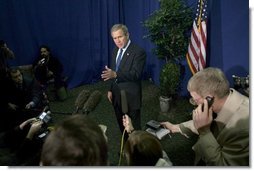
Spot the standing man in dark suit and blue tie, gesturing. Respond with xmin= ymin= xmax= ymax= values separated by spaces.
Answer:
xmin=101 ymin=24 xmax=146 ymax=135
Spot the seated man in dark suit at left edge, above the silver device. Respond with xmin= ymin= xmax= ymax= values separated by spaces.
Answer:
xmin=0 ymin=68 xmax=47 ymax=131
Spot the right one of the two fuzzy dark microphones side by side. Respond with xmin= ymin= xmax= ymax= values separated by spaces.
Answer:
xmin=82 ymin=90 xmax=101 ymax=115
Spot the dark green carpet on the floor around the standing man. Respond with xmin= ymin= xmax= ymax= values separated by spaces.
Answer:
xmin=49 ymin=81 xmax=197 ymax=166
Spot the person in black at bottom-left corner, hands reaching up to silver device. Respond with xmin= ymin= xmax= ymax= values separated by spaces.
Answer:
xmin=0 ymin=118 xmax=43 ymax=166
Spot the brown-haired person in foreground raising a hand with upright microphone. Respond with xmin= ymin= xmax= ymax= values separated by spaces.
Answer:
xmin=123 ymin=115 xmax=172 ymax=166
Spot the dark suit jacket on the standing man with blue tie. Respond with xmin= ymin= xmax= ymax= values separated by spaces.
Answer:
xmin=110 ymin=43 xmax=146 ymax=110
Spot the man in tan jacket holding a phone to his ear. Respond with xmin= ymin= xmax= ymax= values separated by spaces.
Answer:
xmin=161 ymin=68 xmax=249 ymax=166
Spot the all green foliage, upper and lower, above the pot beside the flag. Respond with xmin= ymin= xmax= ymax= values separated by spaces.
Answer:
xmin=143 ymin=0 xmax=193 ymax=112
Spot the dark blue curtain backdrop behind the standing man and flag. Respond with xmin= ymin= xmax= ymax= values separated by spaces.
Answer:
xmin=0 ymin=0 xmax=249 ymax=95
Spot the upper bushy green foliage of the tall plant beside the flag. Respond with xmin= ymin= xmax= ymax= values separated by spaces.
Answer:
xmin=143 ymin=0 xmax=193 ymax=62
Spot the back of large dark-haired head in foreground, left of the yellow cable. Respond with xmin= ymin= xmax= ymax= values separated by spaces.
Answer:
xmin=40 ymin=114 xmax=108 ymax=166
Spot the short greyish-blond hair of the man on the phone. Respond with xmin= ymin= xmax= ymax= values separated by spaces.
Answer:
xmin=187 ymin=67 xmax=230 ymax=98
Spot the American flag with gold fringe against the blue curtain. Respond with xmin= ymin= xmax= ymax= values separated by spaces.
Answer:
xmin=186 ymin=0 xmax=207 ymax=74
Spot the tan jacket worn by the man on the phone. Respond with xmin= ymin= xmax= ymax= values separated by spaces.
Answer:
xmin=180 ymin=89 xmax=249 ymax=166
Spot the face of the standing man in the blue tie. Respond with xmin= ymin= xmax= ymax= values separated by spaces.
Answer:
xmin=111 ymin=29 xmax=129 ymax=49
